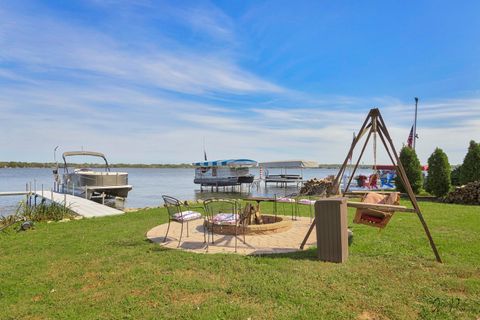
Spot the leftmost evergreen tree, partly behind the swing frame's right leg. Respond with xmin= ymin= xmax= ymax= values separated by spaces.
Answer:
xmin=395 ymin=146 xmax=423 ymax=194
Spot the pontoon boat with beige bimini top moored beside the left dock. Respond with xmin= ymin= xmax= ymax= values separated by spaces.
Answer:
xmin=54 ymin=151 xmax=132 ymax=199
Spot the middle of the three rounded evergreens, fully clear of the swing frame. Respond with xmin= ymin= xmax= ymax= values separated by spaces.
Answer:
xmin=425 ymin=148 xmax=451 ymax=197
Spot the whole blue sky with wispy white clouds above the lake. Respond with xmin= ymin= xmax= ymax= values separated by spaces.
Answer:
xmin=0 ymin=0 xmax=480 ymax=163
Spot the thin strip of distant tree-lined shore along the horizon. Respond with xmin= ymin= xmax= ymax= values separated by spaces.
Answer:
xmin=0 ymin=161 xmax=372 ymax=169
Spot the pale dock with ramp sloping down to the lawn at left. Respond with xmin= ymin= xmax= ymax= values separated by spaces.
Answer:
xmin=0 ymin=190 xmax=124 ymax=218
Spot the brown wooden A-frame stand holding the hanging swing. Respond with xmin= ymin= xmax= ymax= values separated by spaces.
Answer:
xmin=300 ymin=108 xmax=442 ymax=262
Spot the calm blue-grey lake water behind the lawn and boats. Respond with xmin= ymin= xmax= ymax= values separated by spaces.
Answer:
xmin=0 ymin=168 xmax=371 ymax=215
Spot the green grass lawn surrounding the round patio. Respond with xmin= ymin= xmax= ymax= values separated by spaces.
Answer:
xmin=0 ymin=202 xmax=480 ymax=319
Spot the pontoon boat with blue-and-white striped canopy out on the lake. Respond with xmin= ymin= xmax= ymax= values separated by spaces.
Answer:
xmin=193 ymin=159 xmax=257 ymax=187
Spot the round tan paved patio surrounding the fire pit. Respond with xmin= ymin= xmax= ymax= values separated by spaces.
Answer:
xmin=147 ymin=217 xmax=316 ymax=255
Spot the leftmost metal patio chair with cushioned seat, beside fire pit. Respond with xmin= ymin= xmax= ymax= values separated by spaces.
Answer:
xmin=162 ymin=195 xmax=208 ymax=247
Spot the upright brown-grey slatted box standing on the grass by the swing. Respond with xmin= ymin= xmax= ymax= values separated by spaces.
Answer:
xmin=315 ymin=198 xmax=348 ymax=262
